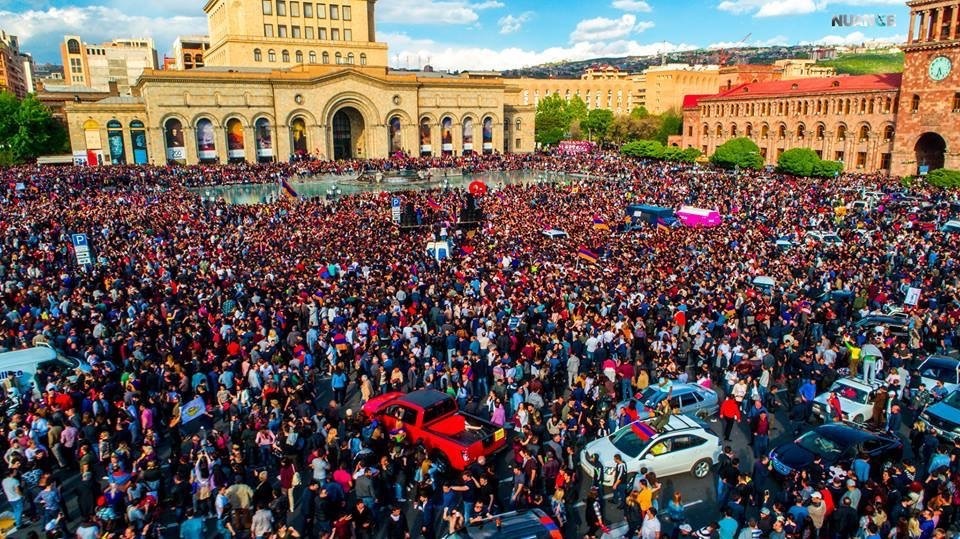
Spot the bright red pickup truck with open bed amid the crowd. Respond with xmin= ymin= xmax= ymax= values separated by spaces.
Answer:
xmin=363 ymin=389 xmax=507 ymax=470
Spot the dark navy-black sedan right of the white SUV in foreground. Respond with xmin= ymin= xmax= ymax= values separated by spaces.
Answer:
xmin=770 ymin=423 xmax=903 ymax=475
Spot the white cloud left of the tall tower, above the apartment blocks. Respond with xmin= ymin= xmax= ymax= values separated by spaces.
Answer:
xmin=0 ymin=6 xmax=207 ymax=63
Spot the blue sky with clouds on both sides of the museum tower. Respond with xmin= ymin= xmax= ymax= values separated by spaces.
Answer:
xmin=0 ymin=0 xmax=909 ymax=69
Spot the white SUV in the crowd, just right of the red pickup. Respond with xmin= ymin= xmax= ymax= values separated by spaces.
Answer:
xmin=580 ymin=415 xmax=720 ymax=485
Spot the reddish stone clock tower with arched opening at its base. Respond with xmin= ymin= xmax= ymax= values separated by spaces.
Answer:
xmin=891 ymin=0 xmax=960 ymax=176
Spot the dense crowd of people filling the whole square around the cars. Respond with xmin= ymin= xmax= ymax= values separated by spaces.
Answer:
xmin=0 ymin=153 xmax=960 ymax=539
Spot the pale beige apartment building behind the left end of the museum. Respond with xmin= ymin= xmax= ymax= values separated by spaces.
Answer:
xmin=60 ymin=35 xmax=158 ymax=95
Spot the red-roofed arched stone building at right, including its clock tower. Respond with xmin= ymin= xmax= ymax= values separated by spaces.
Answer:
xmin=680 ymin=0 xmax=960 ymax=176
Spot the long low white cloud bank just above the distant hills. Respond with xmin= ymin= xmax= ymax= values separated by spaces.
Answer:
xmin=380 ymin=33 xmax=697 ymax=71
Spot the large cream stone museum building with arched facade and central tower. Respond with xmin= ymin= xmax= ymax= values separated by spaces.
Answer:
xmin=65 ymin=0 xmax=534 ymax=165
